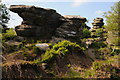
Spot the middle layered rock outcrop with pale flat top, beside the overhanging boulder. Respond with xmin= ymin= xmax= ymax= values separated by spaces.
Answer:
xmin=56 ymin=15 xmax=87 ymax=39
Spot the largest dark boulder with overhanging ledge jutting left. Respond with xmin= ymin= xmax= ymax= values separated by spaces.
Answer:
xmin=10 ymin=5 xmax=62 ymax=37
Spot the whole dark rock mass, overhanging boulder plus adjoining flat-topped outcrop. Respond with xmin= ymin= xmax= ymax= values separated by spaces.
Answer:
xmin=10 ymin=5 xmax=87 ymax=39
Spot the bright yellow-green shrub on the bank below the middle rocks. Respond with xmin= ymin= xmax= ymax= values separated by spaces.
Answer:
xmin=42 ymin=40 xmax=84 ymax=62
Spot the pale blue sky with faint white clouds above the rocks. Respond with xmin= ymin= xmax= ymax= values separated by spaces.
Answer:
xmin=2 ymin=0 xmax=117 ymax=28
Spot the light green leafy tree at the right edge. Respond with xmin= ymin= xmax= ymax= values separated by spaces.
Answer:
xmin=105 ymin=1 xmax=120 ymax=46
